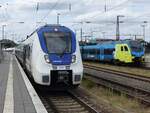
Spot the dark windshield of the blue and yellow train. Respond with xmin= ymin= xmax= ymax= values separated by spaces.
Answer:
xmin=130 ymin=41 xmax=143 ymax=52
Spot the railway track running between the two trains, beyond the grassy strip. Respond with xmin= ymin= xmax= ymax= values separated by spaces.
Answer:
xmin=84 ymin=65 xmax=150 ymax=105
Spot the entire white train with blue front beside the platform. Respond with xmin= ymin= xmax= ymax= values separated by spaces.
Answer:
xmin=15 ymin=25 xmax=83 ymax=87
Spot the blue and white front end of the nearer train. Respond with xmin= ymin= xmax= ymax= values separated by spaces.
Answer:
xmin=34 ymin=26 xmax=83 ymax=87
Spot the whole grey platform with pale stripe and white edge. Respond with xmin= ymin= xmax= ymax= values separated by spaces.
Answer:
xmin=0 ymin=53 xmax=47 ymax=113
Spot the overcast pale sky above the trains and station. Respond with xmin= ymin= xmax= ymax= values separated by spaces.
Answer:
xmin=0 ymin=0 xmax=150 ymax=41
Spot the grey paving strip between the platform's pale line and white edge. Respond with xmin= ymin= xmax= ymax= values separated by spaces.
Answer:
xmin=13 ymin=55 xmax=36 ymax=113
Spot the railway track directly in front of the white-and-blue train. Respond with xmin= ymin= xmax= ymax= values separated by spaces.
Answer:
xmin=39 ymin=91 xmax=99 ymax=113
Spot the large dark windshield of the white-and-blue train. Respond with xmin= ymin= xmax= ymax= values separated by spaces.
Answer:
xmin=44 ymin=32 xmax=71 ymax=54
